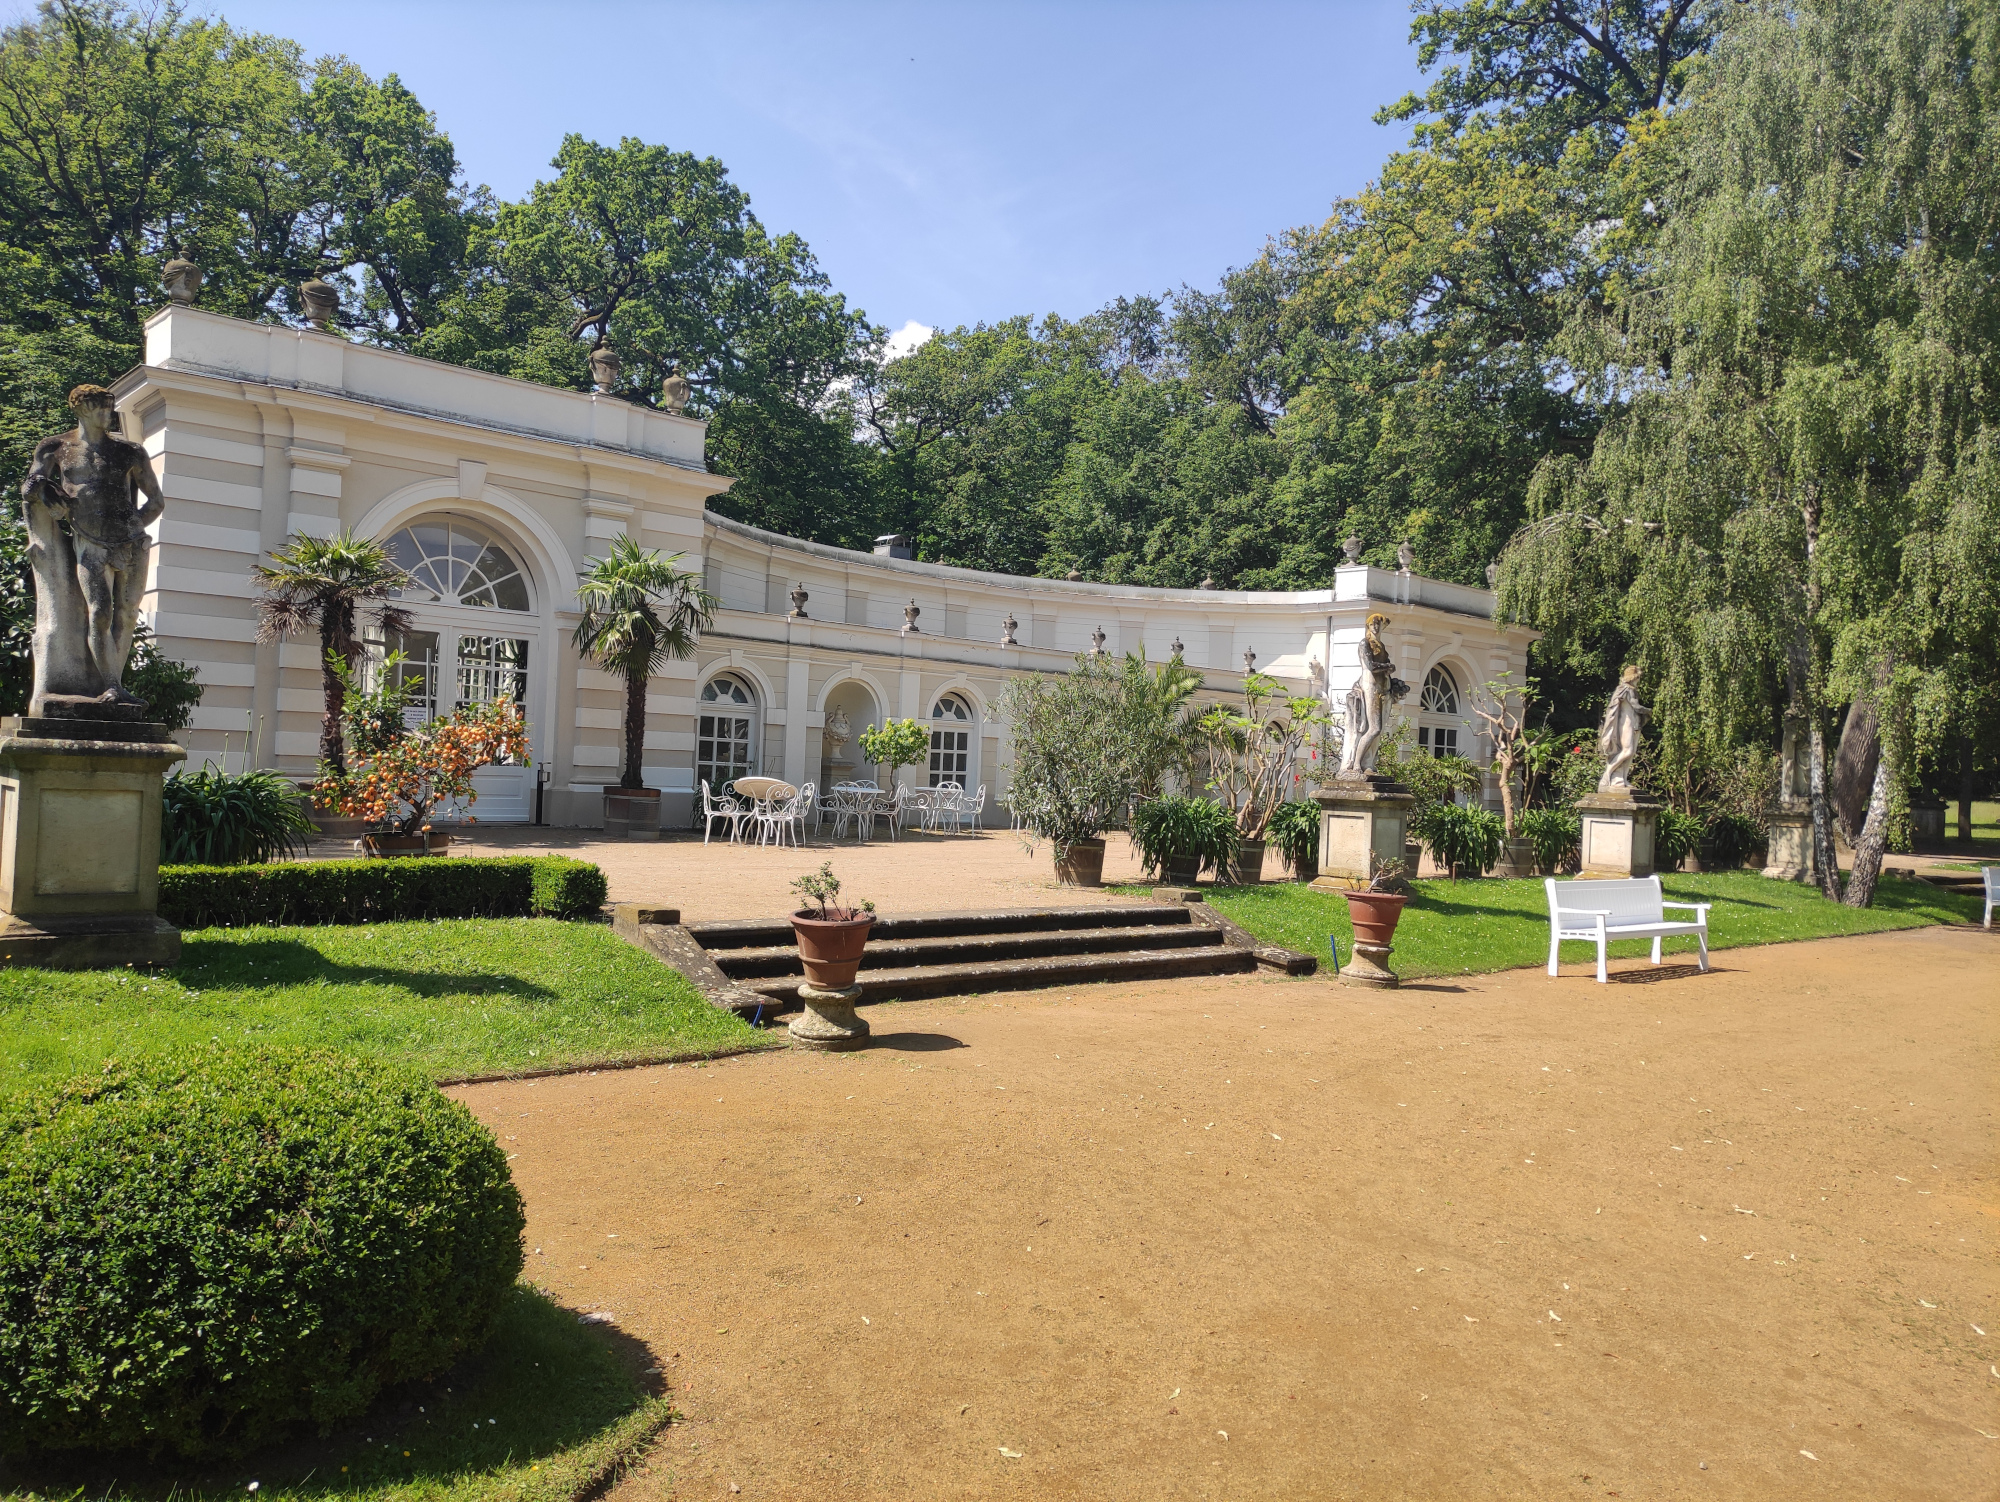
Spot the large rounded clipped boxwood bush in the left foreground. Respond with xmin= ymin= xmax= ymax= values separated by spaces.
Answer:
xmin=0 ymin=1048 xmax=526 ymax=1458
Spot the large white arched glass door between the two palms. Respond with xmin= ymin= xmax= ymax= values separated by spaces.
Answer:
xmin=366 ymin=516 xmax=546 ymax=824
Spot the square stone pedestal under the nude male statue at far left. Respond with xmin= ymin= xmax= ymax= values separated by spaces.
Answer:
xmin=0 ymin=706 xmax=186 ymax=970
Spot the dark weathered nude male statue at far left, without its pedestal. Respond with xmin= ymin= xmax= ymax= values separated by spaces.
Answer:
xmin=20 ymin=386 xmax=166 ymax=714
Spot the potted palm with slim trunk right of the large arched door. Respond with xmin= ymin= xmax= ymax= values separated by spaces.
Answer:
xmin=576 ymin=536 xmax=716 ymax=838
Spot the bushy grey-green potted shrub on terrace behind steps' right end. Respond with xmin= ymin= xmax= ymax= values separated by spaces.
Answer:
xmin=1002 ymin=656 xmax=1132 ymax=886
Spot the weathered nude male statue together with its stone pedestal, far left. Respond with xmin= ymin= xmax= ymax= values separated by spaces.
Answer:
xmin=0 ymin=386 xmax=186 ymax=968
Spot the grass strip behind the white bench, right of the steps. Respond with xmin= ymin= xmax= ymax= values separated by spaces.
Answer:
xmin=1126 ymin=870 xmax=1982 ymax=978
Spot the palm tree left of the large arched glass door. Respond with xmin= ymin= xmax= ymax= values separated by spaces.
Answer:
xmin=252 ymin=532 xmax=410 ymax=800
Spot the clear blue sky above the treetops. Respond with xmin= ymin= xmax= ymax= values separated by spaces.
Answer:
xmin=23 ymin=0 xmax=1418 ymax=344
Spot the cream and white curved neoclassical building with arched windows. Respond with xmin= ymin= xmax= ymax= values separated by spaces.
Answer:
xmin=114 ymin=306 xmax=1532 ymax=826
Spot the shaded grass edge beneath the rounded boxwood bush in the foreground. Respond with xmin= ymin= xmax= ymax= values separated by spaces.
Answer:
xmin=0 ymin=1284 xmax=670 ymax=1502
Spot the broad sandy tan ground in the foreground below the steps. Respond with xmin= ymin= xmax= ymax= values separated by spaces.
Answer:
xmin=458 ymin=924 xmax=2000 ymax=1502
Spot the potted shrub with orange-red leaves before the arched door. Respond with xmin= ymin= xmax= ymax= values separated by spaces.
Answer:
xmin=312 ymin=700 xmax=528 ymax=856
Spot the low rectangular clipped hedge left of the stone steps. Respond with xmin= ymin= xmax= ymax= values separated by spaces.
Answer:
xmin=160 ymin=856 xmax=606 ymax=928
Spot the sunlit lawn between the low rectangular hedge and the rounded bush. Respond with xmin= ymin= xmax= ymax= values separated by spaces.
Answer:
xmin=0 ymin=918 xmax=770 ymax=1092
